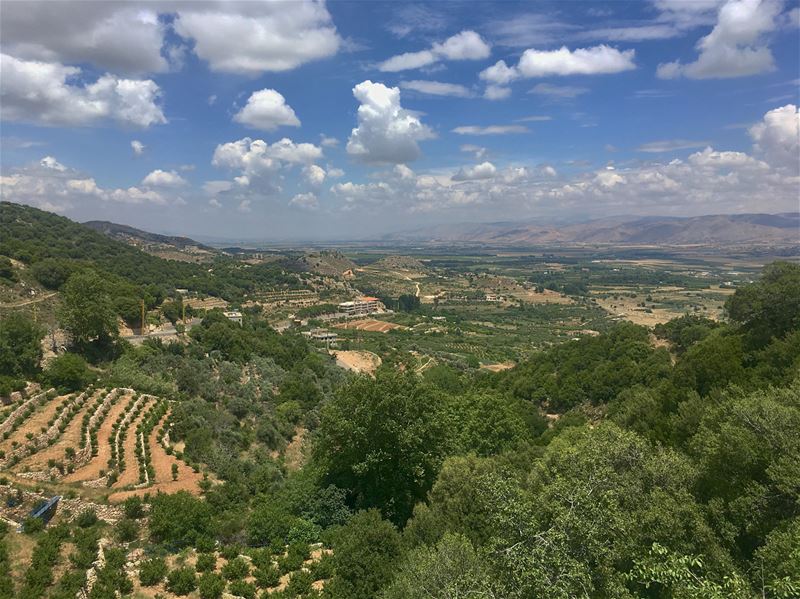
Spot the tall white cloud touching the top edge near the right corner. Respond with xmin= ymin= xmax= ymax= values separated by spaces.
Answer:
xmin=656 ymin=0 xmax=781 ymax=79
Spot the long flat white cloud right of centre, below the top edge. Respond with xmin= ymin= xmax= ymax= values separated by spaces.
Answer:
xmin=480 ymin=44 xmax=636 ymax=86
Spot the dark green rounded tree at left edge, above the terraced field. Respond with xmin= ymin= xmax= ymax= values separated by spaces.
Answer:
xmin=0 ymin=312 xmax=44 ymax=378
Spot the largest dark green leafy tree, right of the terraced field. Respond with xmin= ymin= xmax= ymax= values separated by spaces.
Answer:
xmin=313 ymin=372 xmax=447 ymax=524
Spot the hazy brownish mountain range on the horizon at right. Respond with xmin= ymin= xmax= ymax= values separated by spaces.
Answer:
xmin=383 ymin=213 xmax=800 ymax=246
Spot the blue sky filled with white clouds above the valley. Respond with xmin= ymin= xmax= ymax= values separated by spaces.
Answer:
xmin=0 ymin=0 xmax=800 ymax=241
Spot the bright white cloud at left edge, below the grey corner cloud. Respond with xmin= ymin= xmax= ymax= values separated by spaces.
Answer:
xmin=0 ymin=54 xmax=167 ymax=128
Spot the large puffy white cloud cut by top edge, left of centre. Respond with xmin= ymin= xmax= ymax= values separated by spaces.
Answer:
xmin=174 ymin=0 xmax=342 ymax=75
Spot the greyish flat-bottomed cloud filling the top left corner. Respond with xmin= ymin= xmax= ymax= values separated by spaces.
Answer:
xmin=0 ymin=0 xmax=169 ymax=73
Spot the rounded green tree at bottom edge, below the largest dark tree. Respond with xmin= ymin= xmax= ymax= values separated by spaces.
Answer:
xmin=326 ymin=510 xmax=401 ymax=599
